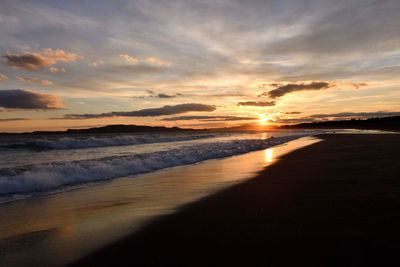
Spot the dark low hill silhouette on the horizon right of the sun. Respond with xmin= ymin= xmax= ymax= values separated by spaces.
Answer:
xmin=281 ymin=116 xmax=400 ymax=131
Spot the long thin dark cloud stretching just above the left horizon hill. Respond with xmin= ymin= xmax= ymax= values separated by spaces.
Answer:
xmin=64 ymin=103 xmax=217 ymax=119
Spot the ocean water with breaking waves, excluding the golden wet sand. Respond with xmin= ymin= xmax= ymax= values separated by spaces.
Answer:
xmin=0 ymin=131 xmax=314 ymax=203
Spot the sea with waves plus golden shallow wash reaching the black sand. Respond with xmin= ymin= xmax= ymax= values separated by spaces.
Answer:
xmin=0 ymin=131 xmax=318 ymax=266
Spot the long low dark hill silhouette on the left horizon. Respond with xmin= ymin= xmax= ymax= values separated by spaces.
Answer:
xmin=0 ymin=124 xmax=193 ymax=135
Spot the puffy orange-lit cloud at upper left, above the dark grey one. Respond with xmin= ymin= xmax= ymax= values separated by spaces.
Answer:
xmin=3 ymin=48 xmax=76 ymax=70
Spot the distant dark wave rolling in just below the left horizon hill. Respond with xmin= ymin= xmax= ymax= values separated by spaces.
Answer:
xmin=4 ymin=134 xmax=215 ymax=150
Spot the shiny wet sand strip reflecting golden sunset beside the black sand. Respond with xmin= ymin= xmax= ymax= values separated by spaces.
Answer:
xmin=0 ymin=137 xmax=319 ymax=266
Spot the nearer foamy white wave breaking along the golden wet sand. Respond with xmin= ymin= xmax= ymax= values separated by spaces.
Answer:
xmin=0 ymin=135 xmax=306 ymax=195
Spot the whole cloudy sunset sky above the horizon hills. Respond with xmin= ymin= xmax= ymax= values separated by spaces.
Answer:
xmin=0 ymin=0 xmax=400 ymax=132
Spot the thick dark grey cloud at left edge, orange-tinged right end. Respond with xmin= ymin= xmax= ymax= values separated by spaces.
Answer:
xmin=0 ymin=89 xmax=63 ymax=110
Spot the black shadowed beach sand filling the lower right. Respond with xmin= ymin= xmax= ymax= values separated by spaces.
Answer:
xmin=76 ymin=134 xmax=400 ymax=266
